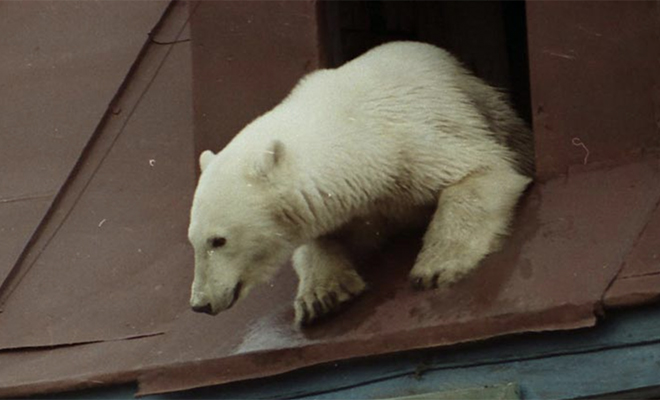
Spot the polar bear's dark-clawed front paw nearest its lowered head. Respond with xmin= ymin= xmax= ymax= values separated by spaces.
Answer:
xmin=294 ymin=271 xmax=366 ymax=327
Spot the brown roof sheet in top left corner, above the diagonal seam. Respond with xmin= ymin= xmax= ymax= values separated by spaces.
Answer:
xmin=0 ymin=0 xmax=167 ymax=284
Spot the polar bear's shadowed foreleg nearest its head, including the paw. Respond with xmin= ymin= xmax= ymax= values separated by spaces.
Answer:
xmin=293 ymin=238 xmax=366 ymax=326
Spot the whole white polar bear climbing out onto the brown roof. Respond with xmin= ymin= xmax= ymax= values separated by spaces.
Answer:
xmin=189 ymin=42 xmax=533 ymax=325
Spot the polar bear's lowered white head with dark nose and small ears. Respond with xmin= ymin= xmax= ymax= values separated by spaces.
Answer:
xmin=188 ymin=141 xmax=295 ymax=315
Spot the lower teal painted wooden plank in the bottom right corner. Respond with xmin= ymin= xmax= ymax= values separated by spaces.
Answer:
xmin=298 ymin=343 xmax=660 ymax=400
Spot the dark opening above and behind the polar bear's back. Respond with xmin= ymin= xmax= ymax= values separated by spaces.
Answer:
xmin=322 ymin=1 xmax=531 ymax=123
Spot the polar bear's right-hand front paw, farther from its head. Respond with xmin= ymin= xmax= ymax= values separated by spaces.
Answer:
xmin=410 ymin=260 xmax=476 ymax=290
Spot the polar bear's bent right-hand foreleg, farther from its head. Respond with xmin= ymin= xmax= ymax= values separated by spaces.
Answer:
xmin=410 ymin=168 xmax=530 ymax=289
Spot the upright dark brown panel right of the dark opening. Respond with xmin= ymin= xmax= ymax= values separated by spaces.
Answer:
xmin=526 ymin=1 xmax=660 ymax=179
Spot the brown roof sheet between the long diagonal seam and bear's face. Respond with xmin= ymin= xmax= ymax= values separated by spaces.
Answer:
xmin=0 ymin=7 xmax=195 ymax=349
